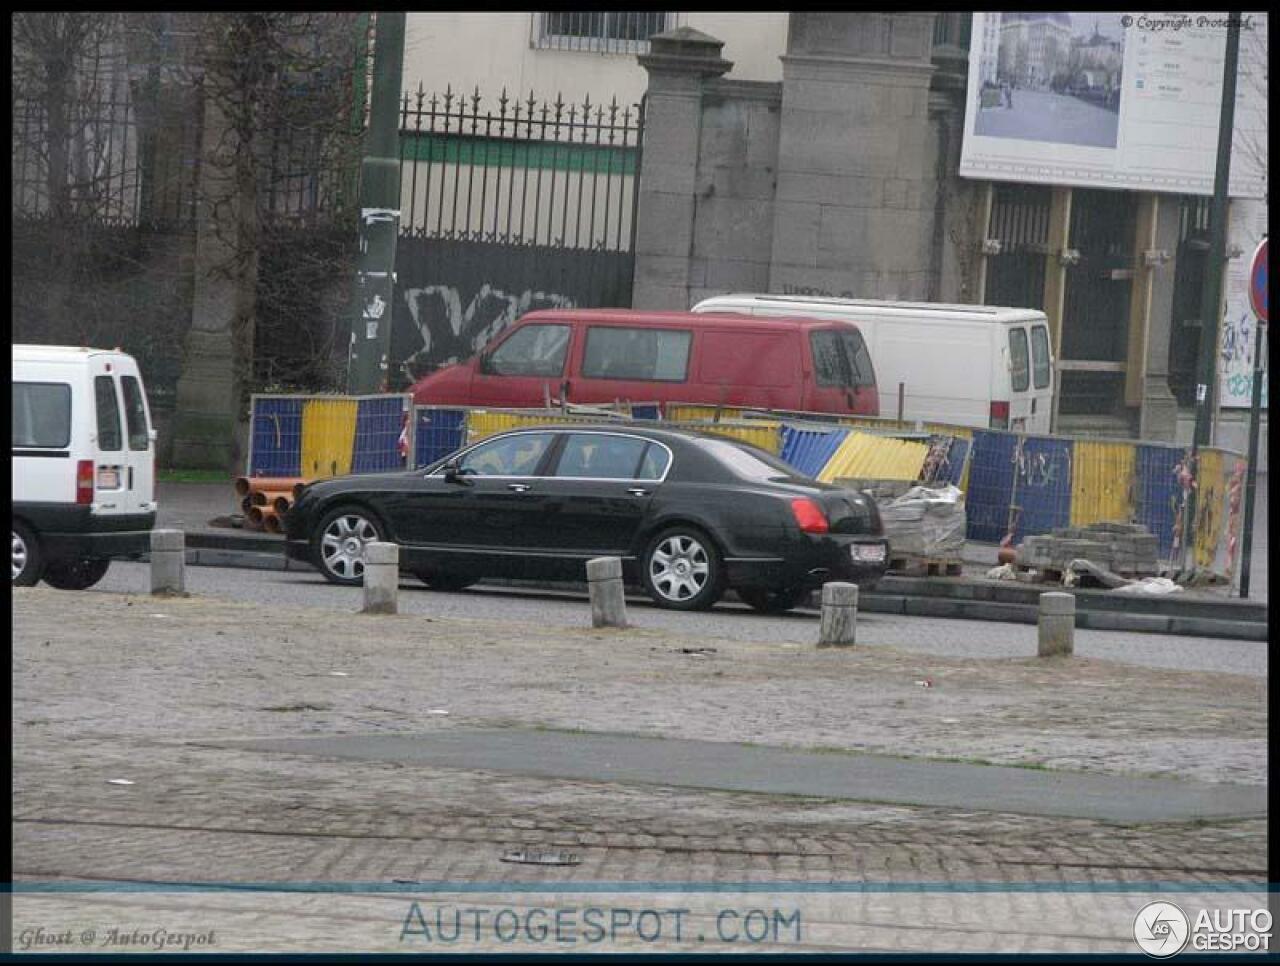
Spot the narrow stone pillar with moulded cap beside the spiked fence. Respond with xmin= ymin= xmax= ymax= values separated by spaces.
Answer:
xmin=631 ymin=27 xmax=733 ymax=310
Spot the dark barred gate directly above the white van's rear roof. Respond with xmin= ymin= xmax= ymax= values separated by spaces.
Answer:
xmin=983 ymin=184 xmax=1052 ymax=308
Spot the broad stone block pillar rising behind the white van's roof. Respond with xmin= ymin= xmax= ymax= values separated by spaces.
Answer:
xmin=768 ymin=10 xmax=937 ymax=299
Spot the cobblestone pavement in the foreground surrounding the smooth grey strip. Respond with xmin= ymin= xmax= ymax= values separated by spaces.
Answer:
xmin=13 ymin=589 xmax=1267 ymax=952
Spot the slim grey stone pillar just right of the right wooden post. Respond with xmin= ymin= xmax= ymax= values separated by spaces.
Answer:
xmin=1138 ymin=194 xmax=1180 ymax=443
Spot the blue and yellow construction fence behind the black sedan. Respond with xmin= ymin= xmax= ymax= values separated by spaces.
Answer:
xmin=247 ymin=394 xmax=1245 ymax=576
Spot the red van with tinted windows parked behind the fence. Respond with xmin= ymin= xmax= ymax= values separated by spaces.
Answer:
xmin=413 ymin=308 xmax=879 ymax=416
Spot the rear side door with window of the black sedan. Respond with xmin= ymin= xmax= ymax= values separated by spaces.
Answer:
xmin=539 ymin=431 xmax=671 ymax=566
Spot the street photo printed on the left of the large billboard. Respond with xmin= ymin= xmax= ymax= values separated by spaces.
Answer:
xmin=973 ymin=12 xmax=1125 ymax=148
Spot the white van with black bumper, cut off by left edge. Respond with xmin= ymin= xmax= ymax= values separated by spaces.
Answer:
xmin=13 ymin=345 xmax=156 ymax=590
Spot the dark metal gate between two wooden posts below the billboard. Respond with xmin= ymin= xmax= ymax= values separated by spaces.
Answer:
xmin=1059 ymin=188 xmax=1138 ymax=416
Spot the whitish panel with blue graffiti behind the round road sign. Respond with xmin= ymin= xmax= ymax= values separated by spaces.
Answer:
xmin=1217 ymin=200 xmax=1267 ymax=409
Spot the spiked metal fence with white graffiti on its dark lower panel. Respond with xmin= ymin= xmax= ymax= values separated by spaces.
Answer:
xmin=392 ymin=87 xmax=644 ymax=386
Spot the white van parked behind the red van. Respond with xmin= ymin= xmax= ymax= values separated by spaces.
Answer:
xmin=692 ymin=296 xmax=1053 ymax=432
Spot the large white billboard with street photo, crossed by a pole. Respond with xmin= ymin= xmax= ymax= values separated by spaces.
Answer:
xmin=960 ymin=12 xmax=1267 ymax=198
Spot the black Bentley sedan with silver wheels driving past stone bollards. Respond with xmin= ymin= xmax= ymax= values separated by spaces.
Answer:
xmin=285 ymin=424 xmax=888 ymax=612
